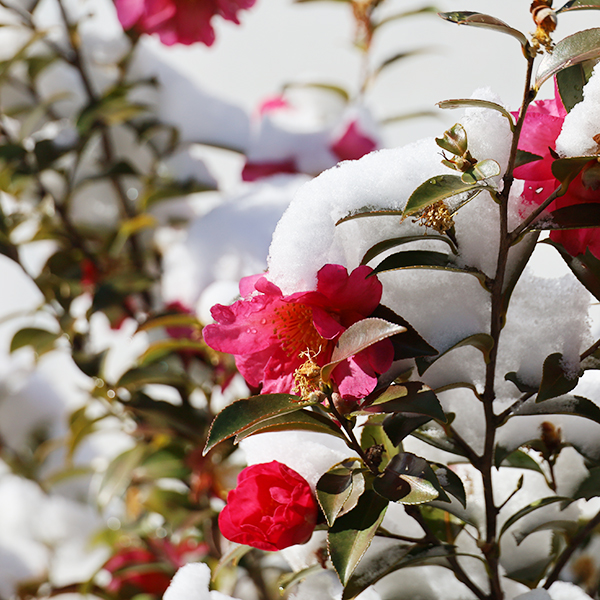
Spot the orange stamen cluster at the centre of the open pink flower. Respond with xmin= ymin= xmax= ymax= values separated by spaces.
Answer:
xmin=273 ymin=302 xmax=324 ymax=358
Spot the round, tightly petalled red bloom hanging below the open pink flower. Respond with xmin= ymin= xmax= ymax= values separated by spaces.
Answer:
xmin=219 ymin=460 xmax=318 ymax=551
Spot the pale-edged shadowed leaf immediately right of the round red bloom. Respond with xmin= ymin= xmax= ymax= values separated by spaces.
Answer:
xmin=316 ymin=458 xmax=365 ymax=527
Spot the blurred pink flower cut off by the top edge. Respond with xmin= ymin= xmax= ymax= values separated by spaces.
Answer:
xmin=115 ymin=0 xmax=256 ymax=46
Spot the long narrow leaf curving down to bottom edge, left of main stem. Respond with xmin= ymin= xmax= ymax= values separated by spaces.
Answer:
xmin=342 ymin=544 xmax=455 ymax=600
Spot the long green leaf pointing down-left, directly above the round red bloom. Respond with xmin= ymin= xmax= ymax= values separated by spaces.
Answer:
xmin=203 ymin=394 xmax=313 ymax=455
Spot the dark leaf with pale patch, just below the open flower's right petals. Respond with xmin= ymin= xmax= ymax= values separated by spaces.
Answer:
xmin=361 ymin=381 xmax=446 ymax=423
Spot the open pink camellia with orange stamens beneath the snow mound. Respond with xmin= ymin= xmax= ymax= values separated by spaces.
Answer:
xmin=203 ymin=265 xmax=394 ymax=400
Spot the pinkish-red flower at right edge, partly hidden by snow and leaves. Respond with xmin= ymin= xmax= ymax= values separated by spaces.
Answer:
xmin=515 ymin=86 xmax=600 ymax=258
